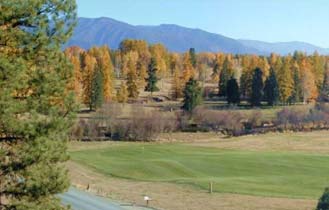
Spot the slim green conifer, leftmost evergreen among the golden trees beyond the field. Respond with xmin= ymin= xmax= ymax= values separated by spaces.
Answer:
xmin=90 ymin=69 xmax=104 ymax=110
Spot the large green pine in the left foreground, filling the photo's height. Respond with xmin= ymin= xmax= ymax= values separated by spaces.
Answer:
xmin=0 ymin=0 xmax=76 ymax=210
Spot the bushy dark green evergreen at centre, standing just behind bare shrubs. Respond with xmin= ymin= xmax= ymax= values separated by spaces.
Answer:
xmin=182 ymin=78 xmax=202 ymax=112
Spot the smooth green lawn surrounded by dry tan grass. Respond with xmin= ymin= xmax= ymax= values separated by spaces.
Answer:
xmin=71 ymin=143 xmax=329 ymax=199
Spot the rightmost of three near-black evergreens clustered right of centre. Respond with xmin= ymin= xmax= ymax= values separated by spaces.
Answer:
xmin=264 ymin=69 xmax=279 ymax=106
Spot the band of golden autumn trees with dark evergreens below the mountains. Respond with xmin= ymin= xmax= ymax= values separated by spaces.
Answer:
xmin=65 ymin=40 xmax=329 ymax=109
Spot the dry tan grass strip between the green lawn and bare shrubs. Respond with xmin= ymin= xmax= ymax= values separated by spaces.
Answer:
xmin=69 ymin=131 xmax=329 ymax=154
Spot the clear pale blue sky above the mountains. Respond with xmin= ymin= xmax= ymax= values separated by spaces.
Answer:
xmin=77 ymin=0 xmax=329 ymax=48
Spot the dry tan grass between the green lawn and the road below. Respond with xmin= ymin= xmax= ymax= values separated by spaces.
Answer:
xmin=67 ymin=162 xmax=316 ymax=210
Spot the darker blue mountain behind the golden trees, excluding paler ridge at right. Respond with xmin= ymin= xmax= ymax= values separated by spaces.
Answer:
xmin=66 ymin=18 xmax=260 ymax=54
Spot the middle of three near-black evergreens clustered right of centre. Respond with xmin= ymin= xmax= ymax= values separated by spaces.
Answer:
xmin=250 ymin=68 xmax=264 ymax=106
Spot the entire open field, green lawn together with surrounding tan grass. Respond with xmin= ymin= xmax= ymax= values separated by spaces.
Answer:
xmin=69 ymin=131 xmax=329 ymax=209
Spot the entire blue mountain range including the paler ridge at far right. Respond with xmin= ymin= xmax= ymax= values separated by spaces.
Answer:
xmin=65 ymin=17 xmax=329 ymax=55
